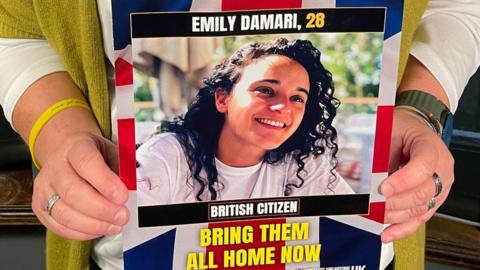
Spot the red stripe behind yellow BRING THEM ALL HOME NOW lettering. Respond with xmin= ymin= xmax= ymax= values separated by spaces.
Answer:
xmin=203 ymin=218 xmax=284 ymax=270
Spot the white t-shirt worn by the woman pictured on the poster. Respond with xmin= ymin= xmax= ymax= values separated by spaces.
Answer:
xmin=137 ymin=133 xmax=354 ymax=205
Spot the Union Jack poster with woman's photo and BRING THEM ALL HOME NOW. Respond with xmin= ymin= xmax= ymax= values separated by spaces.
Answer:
xmin=112 ymin=0 xmax=403 ymax=270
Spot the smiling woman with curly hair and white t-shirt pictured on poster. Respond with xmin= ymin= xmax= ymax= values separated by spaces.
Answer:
xmin=136 ymin=38 xmax=353 ymax=205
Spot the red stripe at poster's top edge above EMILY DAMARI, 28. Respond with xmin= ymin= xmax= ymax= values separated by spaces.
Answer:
xmin=222 ymin=0 xmax=302 ymax=11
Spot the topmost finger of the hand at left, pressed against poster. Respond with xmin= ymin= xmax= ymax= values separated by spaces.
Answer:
xmin=67 ymin=140 xmax=128 ymax=204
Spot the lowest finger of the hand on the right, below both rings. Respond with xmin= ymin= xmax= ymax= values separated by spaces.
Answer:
xmin=381 ymin=209 xmax=435 ymax=243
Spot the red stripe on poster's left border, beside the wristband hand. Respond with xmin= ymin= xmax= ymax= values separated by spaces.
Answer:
xmin=117 ymin=118 xmax=137 ymax=190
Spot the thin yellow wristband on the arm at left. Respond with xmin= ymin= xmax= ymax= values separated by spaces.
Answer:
xmin=28 ymin=98 xmax=91 ymax=169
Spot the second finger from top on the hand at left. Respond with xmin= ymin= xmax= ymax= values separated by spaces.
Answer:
xmin=47 ymin=167 xmax=128 ymax=225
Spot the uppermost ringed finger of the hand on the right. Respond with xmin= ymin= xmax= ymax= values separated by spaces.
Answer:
xmin=385 ymin=176 xmax=435 ymax=210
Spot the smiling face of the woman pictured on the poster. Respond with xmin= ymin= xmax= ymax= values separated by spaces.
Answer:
xmin=215 ymin=55 xmax=310 ymax=153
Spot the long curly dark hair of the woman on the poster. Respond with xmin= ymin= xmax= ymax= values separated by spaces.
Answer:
xmin=160 ymin=38 xmax=340 ymax=201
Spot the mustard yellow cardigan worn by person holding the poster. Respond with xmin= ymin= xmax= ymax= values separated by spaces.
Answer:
xmin=0 ymin=0 xmax=428 ymax=270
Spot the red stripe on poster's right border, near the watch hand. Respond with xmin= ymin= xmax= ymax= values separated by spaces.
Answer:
xmin=372 ymin=106 xmax=394 ymax=173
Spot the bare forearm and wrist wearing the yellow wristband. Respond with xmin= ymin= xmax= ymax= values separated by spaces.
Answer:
xmin=12 ymin=72 xmax=101 ymax=169
